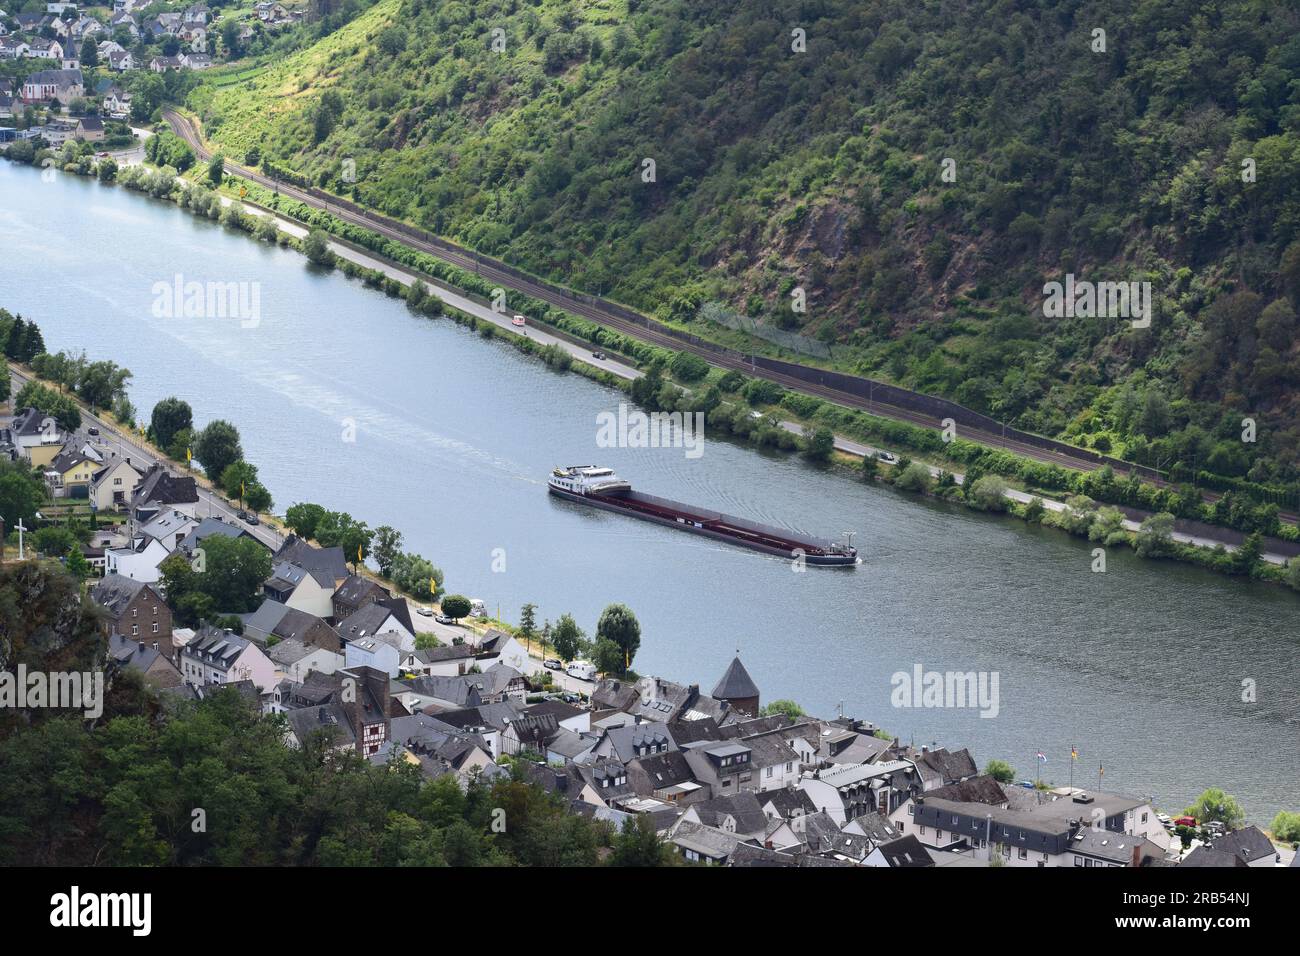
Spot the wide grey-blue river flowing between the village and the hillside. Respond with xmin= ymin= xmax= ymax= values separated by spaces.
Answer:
xmin=0 ymin=161 xmax=1300 ymax=822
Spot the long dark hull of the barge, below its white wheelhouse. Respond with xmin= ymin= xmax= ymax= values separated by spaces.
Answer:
xmin=549 ymin=486 xmax=857 ymax=566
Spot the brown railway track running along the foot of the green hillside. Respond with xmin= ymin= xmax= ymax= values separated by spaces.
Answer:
xmin=163 ymin=109 xmax=1300 ymax=522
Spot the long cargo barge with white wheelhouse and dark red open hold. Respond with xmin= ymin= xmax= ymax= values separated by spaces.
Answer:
xmin=546 ymin=464 xmax=858 ymax=566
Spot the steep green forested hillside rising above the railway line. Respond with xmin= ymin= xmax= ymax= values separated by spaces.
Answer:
xmin=190 ymin=0 xmax=1300 ymax=483
